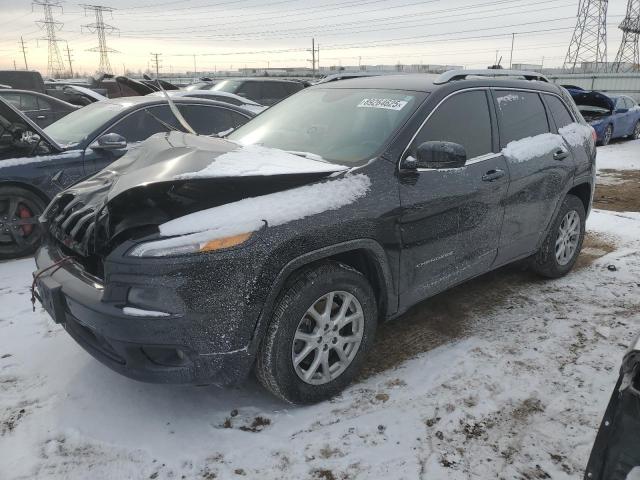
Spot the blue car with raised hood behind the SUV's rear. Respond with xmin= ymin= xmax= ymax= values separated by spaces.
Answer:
xmin=568 ymin=87 xmax=640 ymax=145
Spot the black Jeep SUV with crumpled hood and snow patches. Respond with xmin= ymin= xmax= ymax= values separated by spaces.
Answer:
xmin=35 ymin=71 xmax=596 ymax=403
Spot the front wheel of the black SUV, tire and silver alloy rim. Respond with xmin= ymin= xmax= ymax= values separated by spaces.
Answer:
xmin=255 ymin=262 xmax=378 ymax=404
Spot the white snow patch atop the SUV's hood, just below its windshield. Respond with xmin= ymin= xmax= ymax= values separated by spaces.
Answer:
xmin=175 ymin=145 xmax=349 ymax=180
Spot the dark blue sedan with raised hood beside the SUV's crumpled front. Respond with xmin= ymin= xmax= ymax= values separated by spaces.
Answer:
xmin=0 ymin=97 xmax=254 ymax=259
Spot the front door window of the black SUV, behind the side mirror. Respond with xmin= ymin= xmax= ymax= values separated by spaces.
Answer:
xmin=412 ymin=91 xmax=492 ymax=158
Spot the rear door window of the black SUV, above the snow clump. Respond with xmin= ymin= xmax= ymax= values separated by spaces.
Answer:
xmin=496 ymin=90 xmax=549 ymax=147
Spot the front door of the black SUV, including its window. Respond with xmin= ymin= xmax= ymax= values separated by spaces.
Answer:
xmin=400 ymin=90 xmax=509 ymax=306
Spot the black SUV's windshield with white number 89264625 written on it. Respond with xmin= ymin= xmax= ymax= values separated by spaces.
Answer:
xmin=227 ymin=88 xmax=424 ymax=164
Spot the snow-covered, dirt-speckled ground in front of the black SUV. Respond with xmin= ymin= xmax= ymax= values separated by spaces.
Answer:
xmin=0 ymin=207 xmax=640 ymax=479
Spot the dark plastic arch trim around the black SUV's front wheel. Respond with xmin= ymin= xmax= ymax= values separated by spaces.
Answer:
xmin=249 ymin=238 xmax=398 ymax=354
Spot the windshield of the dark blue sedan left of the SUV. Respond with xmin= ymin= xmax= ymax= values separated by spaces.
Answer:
xmin=44 ymin=102 xmax=127 ymax=145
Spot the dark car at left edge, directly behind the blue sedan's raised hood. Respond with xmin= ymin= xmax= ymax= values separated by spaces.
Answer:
xmin=0 ymin=89 xmax=81 ymax=128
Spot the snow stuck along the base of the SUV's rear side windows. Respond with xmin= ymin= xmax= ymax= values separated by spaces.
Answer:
xmin=502 ymin=123 xmax=592 ymax=163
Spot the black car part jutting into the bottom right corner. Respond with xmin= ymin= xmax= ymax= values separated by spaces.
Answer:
xmin=585 ymin=336 xmax=640 ymax=480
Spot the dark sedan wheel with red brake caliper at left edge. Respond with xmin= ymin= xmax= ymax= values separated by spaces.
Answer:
xmin=0 ymin=187 xmax=45 ymax=260
